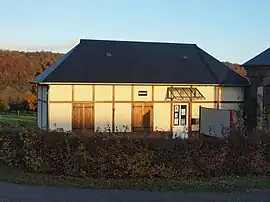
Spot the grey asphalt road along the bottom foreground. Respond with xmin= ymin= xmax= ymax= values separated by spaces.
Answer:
xmin=0 ymin=182 xmax=270 ymax=202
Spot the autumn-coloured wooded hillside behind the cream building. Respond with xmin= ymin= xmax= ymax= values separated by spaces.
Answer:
xmin=0 ymin=50 xmax=246 ymax=111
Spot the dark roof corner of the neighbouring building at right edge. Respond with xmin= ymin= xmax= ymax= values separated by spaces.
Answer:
xmin=242 ymin=48 xmax=270 ymax=66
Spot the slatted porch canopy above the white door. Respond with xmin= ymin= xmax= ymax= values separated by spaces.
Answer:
xmin=167 ymin=87 xmax=205 ymax=100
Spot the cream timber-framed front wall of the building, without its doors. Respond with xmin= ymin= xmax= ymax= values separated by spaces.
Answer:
xmin=49 ymin=85 xmax=243 ymax=131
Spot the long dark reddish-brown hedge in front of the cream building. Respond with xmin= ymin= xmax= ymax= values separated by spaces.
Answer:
xmin=0 ymin=122 xmax=270 ymax=179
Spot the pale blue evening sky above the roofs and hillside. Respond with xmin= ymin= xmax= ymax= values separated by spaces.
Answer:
xmin=0 ymin=0 xmax=270 ymax=64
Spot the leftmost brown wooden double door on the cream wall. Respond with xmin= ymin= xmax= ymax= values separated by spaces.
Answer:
xmin=72 ymin=103 xmax=94 ymax=132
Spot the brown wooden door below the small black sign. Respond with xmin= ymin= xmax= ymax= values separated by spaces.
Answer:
xmin=132 ymin=103 xmax=153 ymax=132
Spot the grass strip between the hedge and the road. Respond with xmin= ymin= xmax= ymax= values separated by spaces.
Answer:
xmin=0 ymin=164 xmax=270 ymax=192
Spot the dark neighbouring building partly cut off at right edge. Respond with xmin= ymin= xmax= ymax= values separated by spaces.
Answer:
xmin=242 ymin=48 xmax=270 ymax=129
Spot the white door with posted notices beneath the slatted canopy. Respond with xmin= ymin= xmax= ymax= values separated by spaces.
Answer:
xmin=172 ymin=103 xmax=188 ymax=138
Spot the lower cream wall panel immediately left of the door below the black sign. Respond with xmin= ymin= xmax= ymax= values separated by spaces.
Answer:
xmin=114 ymin=103 xmax=132 ymax=132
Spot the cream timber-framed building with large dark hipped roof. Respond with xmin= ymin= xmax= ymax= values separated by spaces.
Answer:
xmin=33 ymin=39 xmax=249 ymax=137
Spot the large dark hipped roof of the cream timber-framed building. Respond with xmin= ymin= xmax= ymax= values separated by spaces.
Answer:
xmin=33 ymin=40 xmax=249 ymax=85
